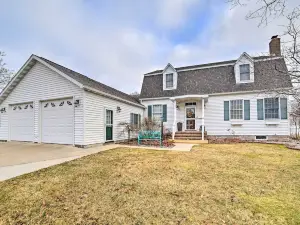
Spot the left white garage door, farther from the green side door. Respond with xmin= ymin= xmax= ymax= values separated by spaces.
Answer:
xmin=9 ymin=102 xmax=34 ymax=141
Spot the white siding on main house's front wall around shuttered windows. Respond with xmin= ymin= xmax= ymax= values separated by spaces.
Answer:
xmin=142 ymin=93 xmax=289 ymax=135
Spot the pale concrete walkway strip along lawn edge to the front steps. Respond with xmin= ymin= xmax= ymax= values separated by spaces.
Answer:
xmin=0 ymin=143 xmax=194 ymax=181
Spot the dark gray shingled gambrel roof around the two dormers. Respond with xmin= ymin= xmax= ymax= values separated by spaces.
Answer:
xmin=140 ymin=56 xmax=292 ymax=99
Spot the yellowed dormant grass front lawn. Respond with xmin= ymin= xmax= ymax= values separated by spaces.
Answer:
xmin=0 ymin=144 xmax=300 ymax=224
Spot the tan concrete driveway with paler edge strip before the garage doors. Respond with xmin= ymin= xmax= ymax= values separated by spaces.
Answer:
xmin=0 ymin=142 xmax=118 ymax=181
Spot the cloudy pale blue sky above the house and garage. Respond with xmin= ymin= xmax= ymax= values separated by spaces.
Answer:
xmin=0 ymin=0 xmax=298 ymax=93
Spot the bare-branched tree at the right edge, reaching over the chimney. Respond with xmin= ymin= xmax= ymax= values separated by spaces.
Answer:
xmin=227 ymin=0 xmax=300 ymax=99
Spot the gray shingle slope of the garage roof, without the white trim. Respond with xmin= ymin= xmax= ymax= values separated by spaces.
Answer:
xmin=36 ymin=56 xmax=141 ymax=105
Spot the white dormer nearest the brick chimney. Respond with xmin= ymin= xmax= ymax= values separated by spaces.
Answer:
xmin=234 ymin=52 xmax=254 ymax=84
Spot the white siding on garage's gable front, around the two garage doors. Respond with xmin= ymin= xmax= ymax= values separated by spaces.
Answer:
xmin=0 ymin=63 xmax=83 ymax=145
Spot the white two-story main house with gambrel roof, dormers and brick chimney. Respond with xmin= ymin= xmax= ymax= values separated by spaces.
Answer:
xmin=140 ymin=36 xmax=292 ymax=140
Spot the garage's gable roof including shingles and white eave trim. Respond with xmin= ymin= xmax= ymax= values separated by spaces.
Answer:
xmin=0 ymin=55 xmax=144 ymax=107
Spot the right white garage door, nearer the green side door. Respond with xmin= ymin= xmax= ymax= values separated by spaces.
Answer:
xmin=42 ymin=99 xmax=74 ymax=144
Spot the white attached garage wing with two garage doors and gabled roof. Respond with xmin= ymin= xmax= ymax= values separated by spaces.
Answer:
xmin=0 ymin=55 xmax=144 ymax=146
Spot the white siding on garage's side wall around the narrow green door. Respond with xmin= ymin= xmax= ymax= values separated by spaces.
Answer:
xmin=84 ymin=91 xmax=144 ymax=145
